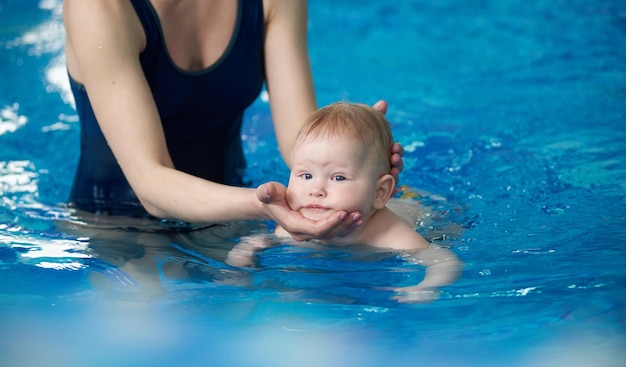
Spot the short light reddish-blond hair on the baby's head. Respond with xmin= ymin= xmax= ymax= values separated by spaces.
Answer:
xmin=296 ymin=102 xmax=393 ymax=172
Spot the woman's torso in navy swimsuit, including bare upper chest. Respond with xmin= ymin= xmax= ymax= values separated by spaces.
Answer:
xmin=68 ymin=0 xmax=265 ymax=215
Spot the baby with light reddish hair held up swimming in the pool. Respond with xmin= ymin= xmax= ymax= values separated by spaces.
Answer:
xmin=227 ymin=102 xmax=463 ymax=302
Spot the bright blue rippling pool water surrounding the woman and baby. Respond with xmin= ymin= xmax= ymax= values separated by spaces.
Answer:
xmin=0 ymin=0 xmax=626 ymax=367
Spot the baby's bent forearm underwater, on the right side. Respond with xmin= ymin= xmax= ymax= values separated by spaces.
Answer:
xmin=393 ymin=245 xmax=464 ymax=303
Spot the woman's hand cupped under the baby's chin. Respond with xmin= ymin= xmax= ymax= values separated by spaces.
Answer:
xmin=256 ymin=182 xmax=363 ymax=241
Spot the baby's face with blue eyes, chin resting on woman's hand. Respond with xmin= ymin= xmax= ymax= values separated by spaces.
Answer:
xmin=287 ymin=139 xmax=378 ymax=220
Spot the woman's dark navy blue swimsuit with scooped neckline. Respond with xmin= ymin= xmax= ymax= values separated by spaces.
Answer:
xmin=70 ymin=0 xmax=264 ymax=216
